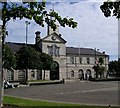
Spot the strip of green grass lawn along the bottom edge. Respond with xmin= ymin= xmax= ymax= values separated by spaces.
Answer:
xmin=3 ymin=96 xmax=120 ymax=108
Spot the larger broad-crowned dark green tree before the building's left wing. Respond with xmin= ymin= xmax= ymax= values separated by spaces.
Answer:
xmin=16 ymin=46 xmax=40 ymax=81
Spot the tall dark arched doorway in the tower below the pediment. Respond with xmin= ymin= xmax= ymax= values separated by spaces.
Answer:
xmin=50 ymin=61 xmax=59 ymax=80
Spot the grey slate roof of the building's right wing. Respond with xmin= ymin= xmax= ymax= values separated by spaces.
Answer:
xmin=66 ymin=47 xmax=108 ymax=56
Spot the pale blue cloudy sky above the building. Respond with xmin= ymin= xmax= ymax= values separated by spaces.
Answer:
xmin=0 ymin=0 xmax=118 ymax=60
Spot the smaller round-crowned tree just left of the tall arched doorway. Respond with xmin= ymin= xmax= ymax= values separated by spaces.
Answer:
xmin=39 ymin=53 xmax=53 ymax=80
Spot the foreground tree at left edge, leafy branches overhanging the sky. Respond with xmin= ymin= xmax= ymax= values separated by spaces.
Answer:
xmin=0 ymin=0 xmax=77 ymax=104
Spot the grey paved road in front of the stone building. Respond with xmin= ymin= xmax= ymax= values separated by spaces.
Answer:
xmin=5 ymin=81 xmax=120 ymax=105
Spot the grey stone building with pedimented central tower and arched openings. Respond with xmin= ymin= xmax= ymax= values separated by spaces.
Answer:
xmin=5 ymin=26 xmax=109 ymax=81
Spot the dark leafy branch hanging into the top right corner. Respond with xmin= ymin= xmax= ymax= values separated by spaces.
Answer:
xmin=100 ymin=0 xmax=120 ymax=19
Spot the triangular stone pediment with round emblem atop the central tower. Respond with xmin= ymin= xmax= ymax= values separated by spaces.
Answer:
xmin=42 ymin=32 xmax=66 ymax=43
